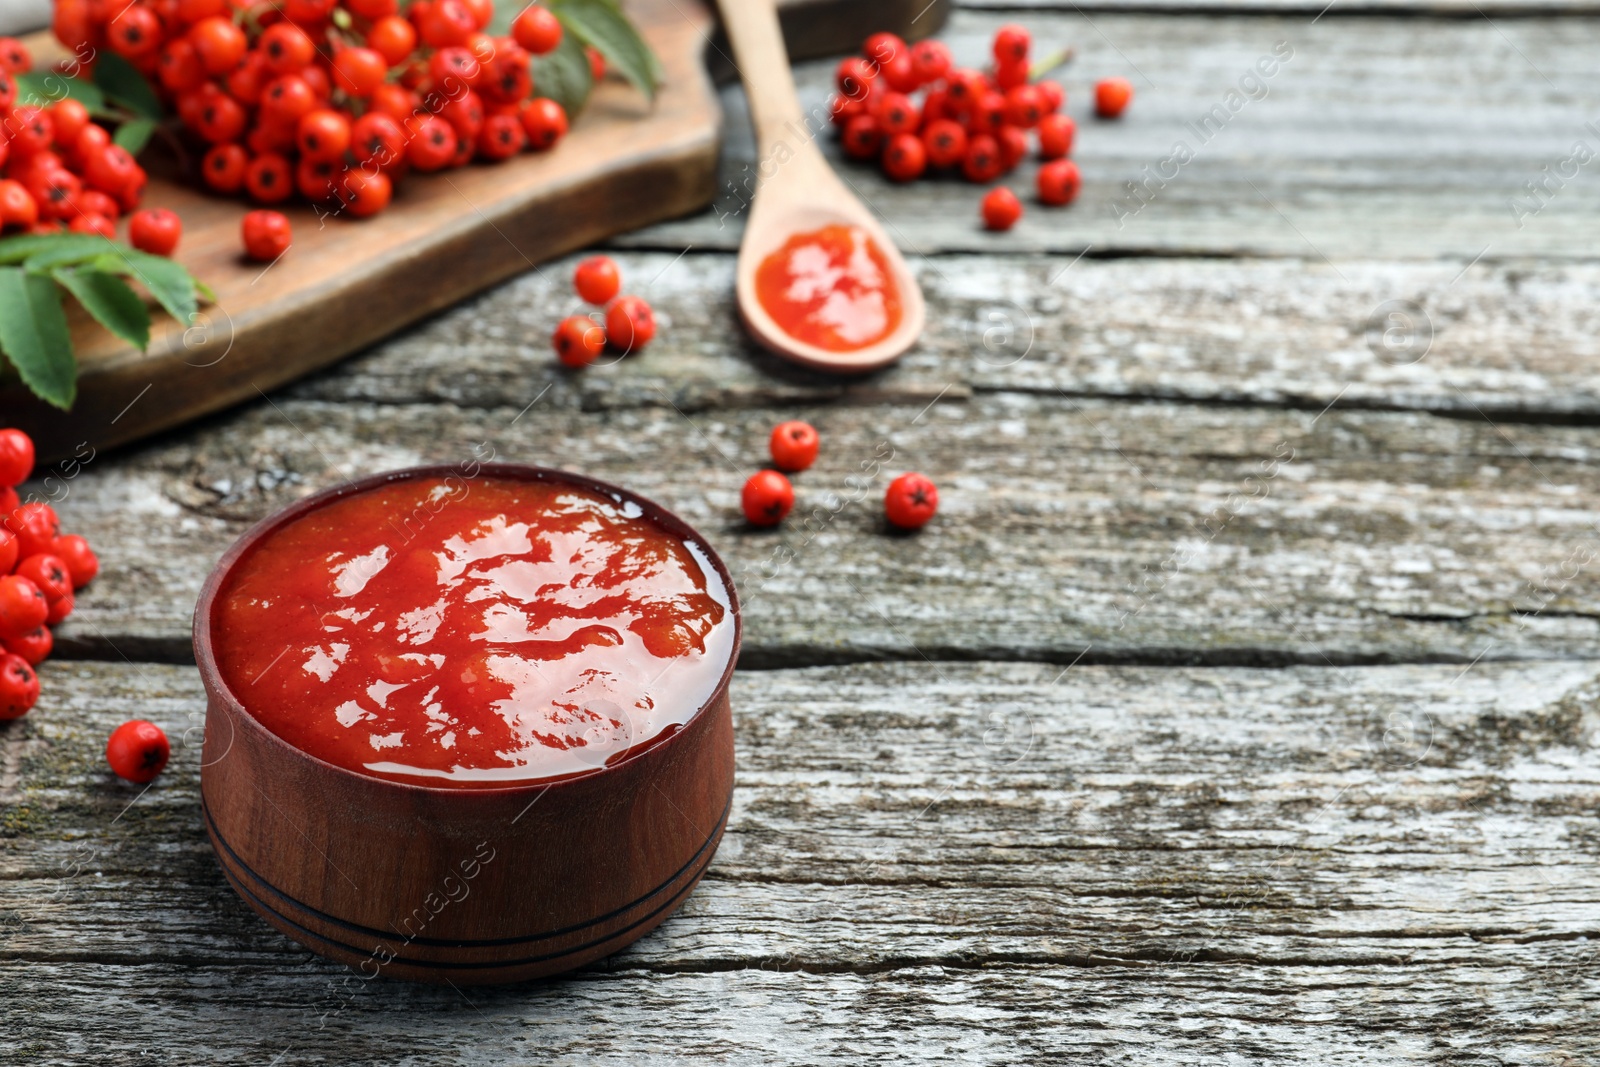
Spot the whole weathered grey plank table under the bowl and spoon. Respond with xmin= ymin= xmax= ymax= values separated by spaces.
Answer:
xmin=0 ymin=0 xmax=1600 ymax=1065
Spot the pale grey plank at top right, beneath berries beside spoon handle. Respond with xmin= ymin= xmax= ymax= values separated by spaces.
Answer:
xmin=621 ymin=11 xmax=1600 ymax=266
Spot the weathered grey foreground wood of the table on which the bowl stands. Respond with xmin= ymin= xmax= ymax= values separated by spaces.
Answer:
xmin=0 ymin=662 xmax=1600 ymax=1064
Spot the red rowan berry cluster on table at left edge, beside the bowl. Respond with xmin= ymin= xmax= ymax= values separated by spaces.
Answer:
xmin=0 ymin=429 xmax=99 ymax=720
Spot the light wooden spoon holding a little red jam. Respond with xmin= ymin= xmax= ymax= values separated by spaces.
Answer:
xmin=722 ymin=0 xmax=926 ymax=374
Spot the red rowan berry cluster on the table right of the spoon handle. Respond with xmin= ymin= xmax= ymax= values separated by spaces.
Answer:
xmin=832 ymin=26 xmax=1133 ymax=229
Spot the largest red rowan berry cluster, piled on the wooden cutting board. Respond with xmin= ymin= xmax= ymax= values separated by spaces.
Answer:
xmin=54 ymin=0 xmax=579 ymax=218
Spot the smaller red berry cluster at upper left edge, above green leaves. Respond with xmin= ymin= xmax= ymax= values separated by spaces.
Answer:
xmin=0 ymin=37 xmax=179 ymax=241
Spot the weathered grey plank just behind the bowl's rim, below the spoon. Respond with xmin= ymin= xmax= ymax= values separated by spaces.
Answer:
xmin=37 ymin=375 xmax=1600 ymax=665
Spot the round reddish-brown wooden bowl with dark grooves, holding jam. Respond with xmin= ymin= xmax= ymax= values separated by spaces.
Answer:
xmin=195 ymin=464 xmax=741 ymax=984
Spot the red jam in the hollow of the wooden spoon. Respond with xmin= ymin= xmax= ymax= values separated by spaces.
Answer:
xmin=755 ymin=226 xmax=901 ymax=352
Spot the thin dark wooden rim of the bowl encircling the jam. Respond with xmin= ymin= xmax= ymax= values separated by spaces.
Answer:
xmin=192 ymin=461 xmax=744 ymax=801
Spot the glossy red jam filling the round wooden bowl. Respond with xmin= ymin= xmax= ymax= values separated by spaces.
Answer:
xmin=213 ymin=477 xmax=734 ymax=787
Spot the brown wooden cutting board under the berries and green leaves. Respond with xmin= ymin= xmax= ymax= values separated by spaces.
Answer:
xmin=0 ymin=0 xmax=950 ymax=462
